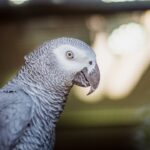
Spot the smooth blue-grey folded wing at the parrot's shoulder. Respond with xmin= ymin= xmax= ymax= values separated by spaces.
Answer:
xmin=0 ymin=90 xmax=34 ymax=150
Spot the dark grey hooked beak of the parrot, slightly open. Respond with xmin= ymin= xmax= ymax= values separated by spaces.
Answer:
xmin=74 ymin=64 xmax=100 ymax=95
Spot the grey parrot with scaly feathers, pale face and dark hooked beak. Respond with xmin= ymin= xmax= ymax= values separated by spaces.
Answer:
xmin=0 ymin=37 xmax=100 ymax=150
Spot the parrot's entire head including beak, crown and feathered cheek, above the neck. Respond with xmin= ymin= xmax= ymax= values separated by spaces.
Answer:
xmin=25 ymin=37 xmax=100 ymax=94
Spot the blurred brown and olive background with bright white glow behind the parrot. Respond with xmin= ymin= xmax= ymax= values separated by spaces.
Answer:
xmin=0 ymin=0 xmax=150 ymax=150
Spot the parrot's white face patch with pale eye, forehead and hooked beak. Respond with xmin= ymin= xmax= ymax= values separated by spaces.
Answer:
xmin=53 ymin=38 xmax=100 ymax=95
